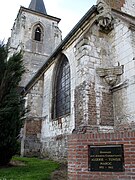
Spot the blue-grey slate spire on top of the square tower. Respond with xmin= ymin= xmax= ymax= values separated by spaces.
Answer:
xmin=28 ymin=0 xmax=47 ymax=14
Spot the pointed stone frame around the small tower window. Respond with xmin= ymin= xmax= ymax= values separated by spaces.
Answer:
xmin=32 ymin=23 xmax=44 ymax=43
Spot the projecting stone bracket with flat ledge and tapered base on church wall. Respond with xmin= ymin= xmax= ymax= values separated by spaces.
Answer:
xmin=96 ymin=66 xmax=124 ymax=86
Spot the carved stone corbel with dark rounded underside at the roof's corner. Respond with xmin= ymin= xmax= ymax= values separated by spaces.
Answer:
xmin=96 ymin=0 xmax=114 ymax=33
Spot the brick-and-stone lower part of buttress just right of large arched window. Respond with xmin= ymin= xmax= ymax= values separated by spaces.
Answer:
xmin=75 ymin=81 xmax=97 ymax=128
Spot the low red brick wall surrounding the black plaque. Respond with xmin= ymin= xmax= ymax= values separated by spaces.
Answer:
xmin=68 ymin=132 xmax=135 ymax=180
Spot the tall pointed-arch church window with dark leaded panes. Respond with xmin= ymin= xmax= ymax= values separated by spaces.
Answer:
xmin=53 ymin=55 xmax=71 ymax=118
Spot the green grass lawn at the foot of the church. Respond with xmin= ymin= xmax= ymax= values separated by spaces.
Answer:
xmin=0 ymin=157 xmax=59 ymax=180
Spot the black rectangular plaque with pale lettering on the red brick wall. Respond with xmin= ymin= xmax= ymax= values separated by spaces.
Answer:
xmin=89 ymin=145 xmax=124 ymax=172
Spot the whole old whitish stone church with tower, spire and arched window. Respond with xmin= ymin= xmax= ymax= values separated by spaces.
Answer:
xmin=10 ymin=0 xmax=135 ymax=159
